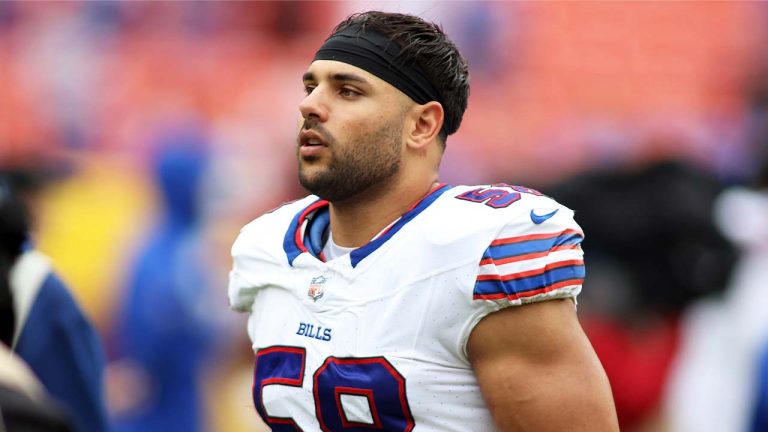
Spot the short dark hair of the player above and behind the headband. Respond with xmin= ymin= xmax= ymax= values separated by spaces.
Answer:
xmin=331 ymin=11 xmax=469 ymax=145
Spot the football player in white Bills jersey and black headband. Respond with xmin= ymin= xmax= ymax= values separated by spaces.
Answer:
xmin=229 ymin=12 xmax=618 ymax=432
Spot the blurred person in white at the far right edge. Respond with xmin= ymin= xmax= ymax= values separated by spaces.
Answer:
xmin=665 ymin=66 xmax=768 ymax=432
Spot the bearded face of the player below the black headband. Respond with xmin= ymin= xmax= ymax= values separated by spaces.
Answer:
xmin=297 ymin=60 xmax=413 ymax=202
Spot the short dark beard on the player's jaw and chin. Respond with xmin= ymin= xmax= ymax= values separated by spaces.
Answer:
xmin=297 ymin=119 xmax=403 ymax=202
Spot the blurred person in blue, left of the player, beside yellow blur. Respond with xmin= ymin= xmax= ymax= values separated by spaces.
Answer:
xmin=108 ymin=123 xmax=215 ymax=432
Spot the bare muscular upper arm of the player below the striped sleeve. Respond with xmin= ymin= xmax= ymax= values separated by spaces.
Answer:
xmin=467 ymin=299 xmax=619 ymax=432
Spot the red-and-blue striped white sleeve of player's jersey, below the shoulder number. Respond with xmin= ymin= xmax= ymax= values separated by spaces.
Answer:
xmin=472 ymin=206 xmax=585 ymax=308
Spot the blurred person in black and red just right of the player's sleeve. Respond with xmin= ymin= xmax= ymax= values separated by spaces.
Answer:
xmin=546 ymin=161 xmax=741 ymax=432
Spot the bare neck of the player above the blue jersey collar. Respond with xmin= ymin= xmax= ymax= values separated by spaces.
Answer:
xmin=330 ymin=177 xmax=435 ymax=247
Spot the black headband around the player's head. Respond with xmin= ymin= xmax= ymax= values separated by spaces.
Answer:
xmin=314 ymin=26 xmax=452 ymax=134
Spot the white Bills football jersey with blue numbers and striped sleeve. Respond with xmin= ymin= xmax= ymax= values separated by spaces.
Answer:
xmin=229 ymin=185 xmax=584 ymax=432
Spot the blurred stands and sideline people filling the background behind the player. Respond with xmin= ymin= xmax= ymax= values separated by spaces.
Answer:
xmin=0 ymin=1 xmax=768 ymax=432
